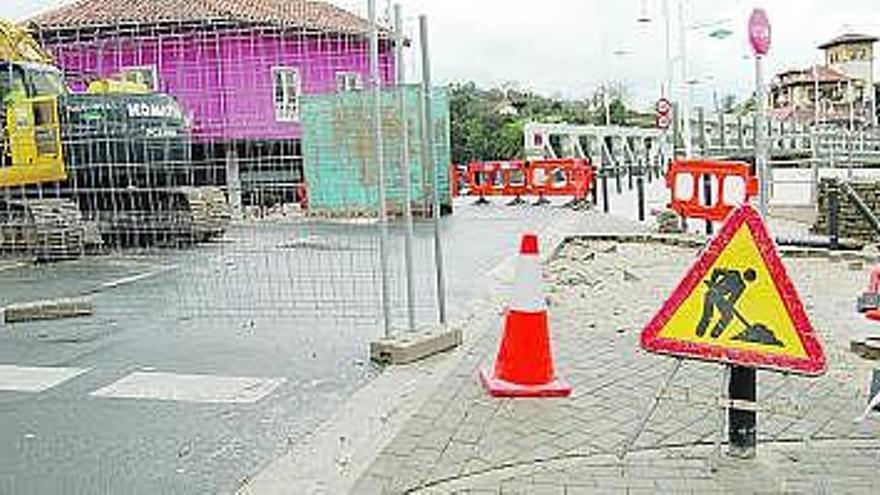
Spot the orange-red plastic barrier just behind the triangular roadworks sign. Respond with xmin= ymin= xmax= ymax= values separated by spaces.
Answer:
xmin=666 ymin=160 xmax=758 ymax=222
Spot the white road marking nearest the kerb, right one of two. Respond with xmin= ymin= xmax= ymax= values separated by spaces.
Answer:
xmin=90 ymin=371 xmax=285 ymax=404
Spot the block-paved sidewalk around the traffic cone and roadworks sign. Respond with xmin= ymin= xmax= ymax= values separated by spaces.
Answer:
xmin=353 ymin=229 xmax=880 ymax=494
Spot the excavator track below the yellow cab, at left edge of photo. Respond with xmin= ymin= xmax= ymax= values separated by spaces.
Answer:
xmin=0 ymin=199 xmax=101 ymax=261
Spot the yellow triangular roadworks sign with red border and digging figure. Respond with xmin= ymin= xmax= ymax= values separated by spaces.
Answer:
xmin=641 ymin=205 xmax=825 ymax=375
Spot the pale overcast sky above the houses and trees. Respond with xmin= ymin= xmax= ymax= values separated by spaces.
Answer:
xmin=0 ymin=0 xmax=880 ymax=110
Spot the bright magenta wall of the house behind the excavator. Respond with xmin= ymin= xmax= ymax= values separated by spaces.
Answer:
xmin=43 ymin=28 xmax=395 ymax=141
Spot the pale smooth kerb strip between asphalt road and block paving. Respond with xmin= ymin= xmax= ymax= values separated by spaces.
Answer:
xmin=239 ymin=207 xmax=646 ymax=495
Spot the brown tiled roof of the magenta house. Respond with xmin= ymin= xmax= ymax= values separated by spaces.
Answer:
xmin=27 ymin=0 xmax=368 ymax=33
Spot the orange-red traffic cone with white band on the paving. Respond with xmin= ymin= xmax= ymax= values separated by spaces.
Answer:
xmin=480 ymin=234 xmax=571 ymax=397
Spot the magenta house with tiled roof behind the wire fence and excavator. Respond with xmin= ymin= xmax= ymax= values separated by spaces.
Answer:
xmin=28 ymin=0 xmax=395 ymax=208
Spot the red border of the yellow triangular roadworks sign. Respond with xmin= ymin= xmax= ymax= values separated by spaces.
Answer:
xmin=640 ymin=204 xmax=826 ymax=375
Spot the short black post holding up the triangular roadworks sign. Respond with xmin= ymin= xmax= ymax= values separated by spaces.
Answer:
xmin=727 ymin=365 xmax=758 ymax=459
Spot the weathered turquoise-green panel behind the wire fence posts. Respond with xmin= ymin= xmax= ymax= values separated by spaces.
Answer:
xmin=300 ymin=85 xmax=451 ymax=214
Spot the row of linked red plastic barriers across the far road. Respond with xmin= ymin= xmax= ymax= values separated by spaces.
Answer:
xmin=452 ymin=158 xmax=594 ymax=201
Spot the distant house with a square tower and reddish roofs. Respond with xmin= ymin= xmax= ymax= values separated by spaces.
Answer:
xmin=770 ymin=34 xmax=878 ymax=126
